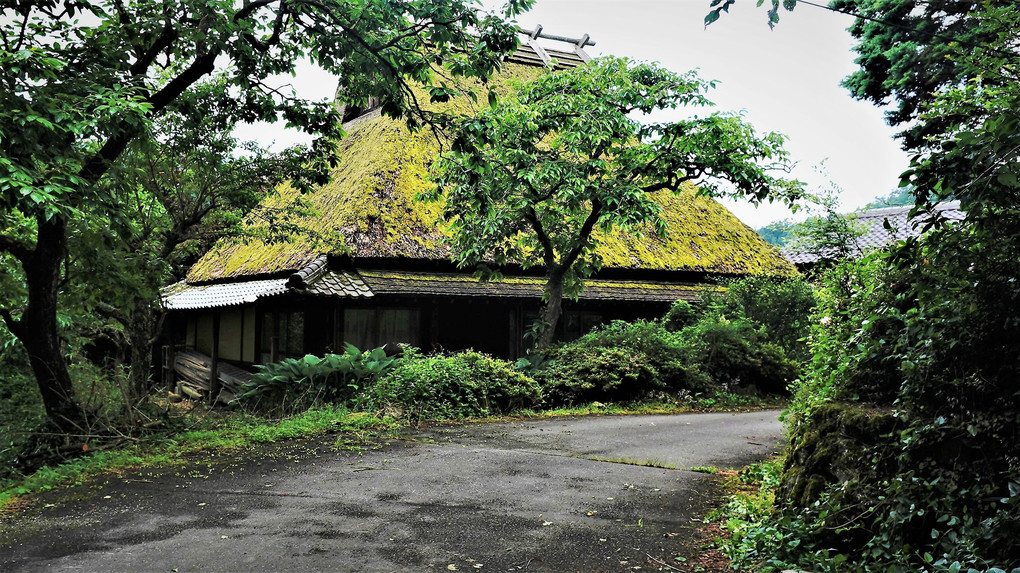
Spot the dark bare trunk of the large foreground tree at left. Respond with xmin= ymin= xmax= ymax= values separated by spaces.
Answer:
xmin=11 ymin=216 xmax=85 ymax=432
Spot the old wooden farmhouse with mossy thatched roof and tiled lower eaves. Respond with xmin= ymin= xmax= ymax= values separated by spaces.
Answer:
xmin=163 ymin=30 xmax=797 ymax=399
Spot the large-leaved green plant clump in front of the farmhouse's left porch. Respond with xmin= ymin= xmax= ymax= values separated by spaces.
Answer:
xmin=237 ymin=344 xmax=398 ymax=411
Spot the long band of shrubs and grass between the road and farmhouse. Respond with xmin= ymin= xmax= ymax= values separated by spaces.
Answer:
xmin=0 ymin=278 xmax=813 ymax=504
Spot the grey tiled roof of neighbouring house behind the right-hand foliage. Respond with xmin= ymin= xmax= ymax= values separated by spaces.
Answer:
xmin=783 ymin=201 xmax=966 ymax=271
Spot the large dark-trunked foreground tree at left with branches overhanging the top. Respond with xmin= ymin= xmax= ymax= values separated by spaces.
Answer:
xmin=0 ymin=0 xmax=530 ymax=430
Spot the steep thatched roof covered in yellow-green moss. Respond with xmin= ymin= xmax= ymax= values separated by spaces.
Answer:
xmin=187 ymin=64 xmax=797 ymax=283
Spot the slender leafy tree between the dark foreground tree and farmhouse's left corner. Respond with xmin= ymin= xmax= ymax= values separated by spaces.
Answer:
xmin=95 ymin=81 xmax=308 ymax=399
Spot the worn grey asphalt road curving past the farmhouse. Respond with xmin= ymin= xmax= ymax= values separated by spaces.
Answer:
xmin=0 ymin=411 xmax=782 ymax=572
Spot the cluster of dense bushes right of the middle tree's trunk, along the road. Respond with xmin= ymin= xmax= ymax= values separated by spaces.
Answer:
xmin=534 ymin=278 xmax=814 ymax=403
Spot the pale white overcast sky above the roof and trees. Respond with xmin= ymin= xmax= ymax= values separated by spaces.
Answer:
xmin=238 ymin=0 xmax=908 ymax=228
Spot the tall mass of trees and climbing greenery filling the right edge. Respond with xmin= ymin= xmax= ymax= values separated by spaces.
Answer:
xmin=713 ymin=0 xmax=1020 ymax=572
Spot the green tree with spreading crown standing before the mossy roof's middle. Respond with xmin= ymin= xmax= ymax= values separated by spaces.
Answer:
xmin=427 ymin=58 xmax=800 ymax=351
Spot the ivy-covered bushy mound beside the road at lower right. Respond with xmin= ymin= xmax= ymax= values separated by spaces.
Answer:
xmin=750 ymin=222 xmax=1020 ymax=571
